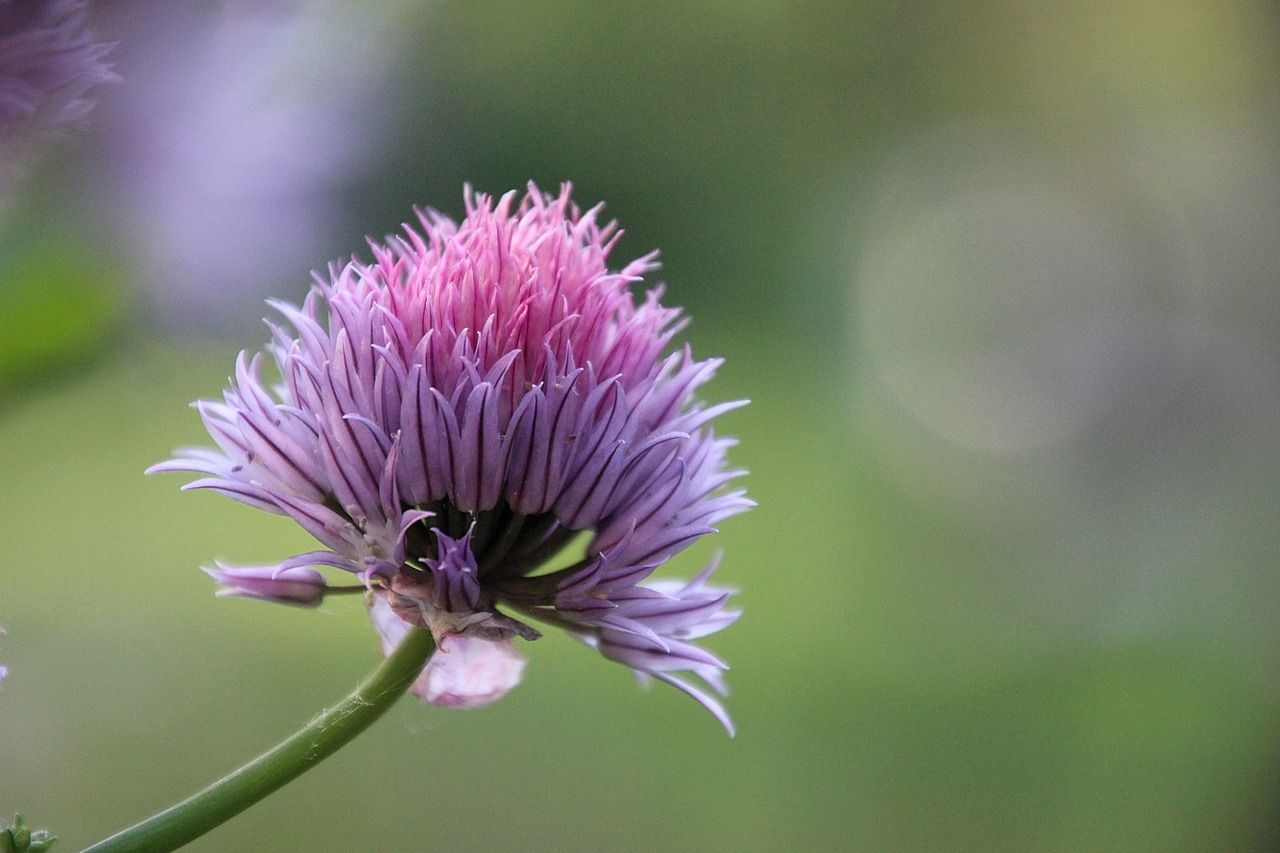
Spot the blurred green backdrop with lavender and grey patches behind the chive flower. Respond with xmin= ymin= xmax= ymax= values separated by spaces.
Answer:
xmin=0 ymin=0 xmax=1280 ymax=850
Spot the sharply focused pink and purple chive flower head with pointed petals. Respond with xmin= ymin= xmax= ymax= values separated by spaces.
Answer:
xmin=151 ymin=186 xmax=751 ymax=733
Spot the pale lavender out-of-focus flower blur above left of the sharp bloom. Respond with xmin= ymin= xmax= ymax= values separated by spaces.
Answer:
xmin=85 ymin=0 xmax=412 ymax=334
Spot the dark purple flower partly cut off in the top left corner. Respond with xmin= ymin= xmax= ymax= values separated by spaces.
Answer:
xmin=0 ymin=0 xmax=114 ymax=149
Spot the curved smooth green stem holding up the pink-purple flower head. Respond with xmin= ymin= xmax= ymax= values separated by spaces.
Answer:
xmin=84 ymin=628 xmax=435 ymax=853
